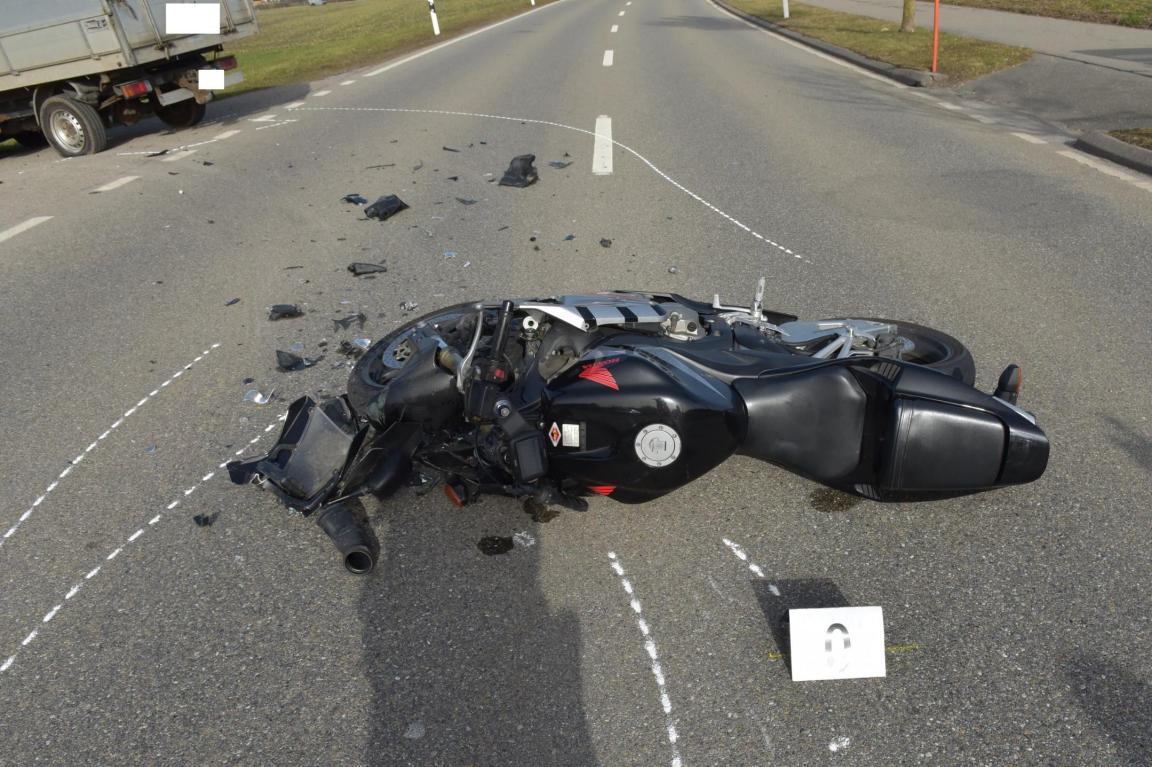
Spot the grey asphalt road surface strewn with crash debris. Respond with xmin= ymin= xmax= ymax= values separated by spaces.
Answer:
xmin=0 ymin=0 xmax=1152 ymax=767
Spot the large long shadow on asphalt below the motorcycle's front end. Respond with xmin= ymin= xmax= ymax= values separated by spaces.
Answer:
xmin=361 ymin=498 xmax=597 ymax=767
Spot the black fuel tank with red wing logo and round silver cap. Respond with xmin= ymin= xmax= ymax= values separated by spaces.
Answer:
xmin=540 ymin=347 xmax=746 ymax=503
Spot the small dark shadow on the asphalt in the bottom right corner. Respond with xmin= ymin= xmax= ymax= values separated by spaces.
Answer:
xmin=1068 ymin=651 xmax=1152 ymax=767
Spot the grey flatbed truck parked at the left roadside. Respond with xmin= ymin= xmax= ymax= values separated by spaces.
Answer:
xmin=0 ymin=0 xmax=257 ymax=157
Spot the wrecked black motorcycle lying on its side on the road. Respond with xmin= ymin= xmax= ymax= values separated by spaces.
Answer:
xmin=228 ymin=280 xmax=1049 ymax=566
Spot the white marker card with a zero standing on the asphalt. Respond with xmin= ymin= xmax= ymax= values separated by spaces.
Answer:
xmin=788 ymin=607 xmax=887 ymax=682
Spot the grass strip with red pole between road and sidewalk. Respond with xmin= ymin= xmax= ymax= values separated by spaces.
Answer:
xmin=726 ymin=0 xmax=1032 ymax=82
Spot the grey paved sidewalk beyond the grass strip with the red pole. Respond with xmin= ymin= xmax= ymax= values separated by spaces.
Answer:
xmin=804 ymin=0 xmax=1152 ymax=130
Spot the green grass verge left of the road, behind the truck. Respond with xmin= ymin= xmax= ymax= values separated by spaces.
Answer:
xmin=227 ymin=0 xmax=548 ymax=96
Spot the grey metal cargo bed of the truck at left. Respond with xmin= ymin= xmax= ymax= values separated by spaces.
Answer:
xmin=0 ymin=0 xmax=256 ymax=93
